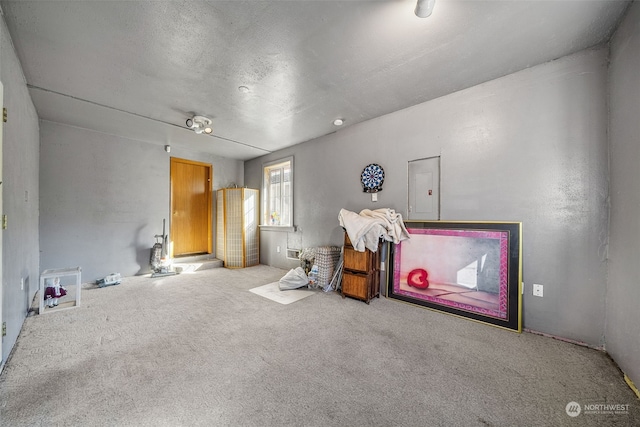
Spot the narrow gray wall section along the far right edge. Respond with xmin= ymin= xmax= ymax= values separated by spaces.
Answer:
xmin=606 ymin=2 xmax=640 ymax=392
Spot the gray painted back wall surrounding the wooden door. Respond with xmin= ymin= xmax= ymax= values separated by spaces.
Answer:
xmin=40 ymin=121 xmax=244 ymax=282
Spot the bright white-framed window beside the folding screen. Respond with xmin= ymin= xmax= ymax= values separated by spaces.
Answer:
xmin=262 ymin=157 xmax=293 ymax=227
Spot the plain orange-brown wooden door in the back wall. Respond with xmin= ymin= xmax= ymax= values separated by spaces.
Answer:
xmin=170 ymin=157 xmax=212 ymax=257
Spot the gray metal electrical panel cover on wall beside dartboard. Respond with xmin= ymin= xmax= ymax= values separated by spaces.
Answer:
xmin=409 ymin=156 xmax=440 ymax=220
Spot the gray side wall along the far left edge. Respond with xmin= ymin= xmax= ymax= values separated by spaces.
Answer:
xmin=0 ymin=18 xmax=40 ymax=362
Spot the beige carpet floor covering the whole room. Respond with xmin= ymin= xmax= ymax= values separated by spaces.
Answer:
xmin=0 ymin=266 xmax=640 ymax=426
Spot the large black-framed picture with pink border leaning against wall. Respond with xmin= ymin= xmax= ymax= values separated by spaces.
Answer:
xmin=387 ymin=221 xmax=522 ymax=332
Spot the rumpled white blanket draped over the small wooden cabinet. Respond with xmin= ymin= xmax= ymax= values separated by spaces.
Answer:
xmin=338 ymin=208 xmax=409 ymax=252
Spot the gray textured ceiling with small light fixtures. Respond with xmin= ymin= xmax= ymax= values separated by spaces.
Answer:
xmin=0 ymin=0 xmax=629 ymax=160
